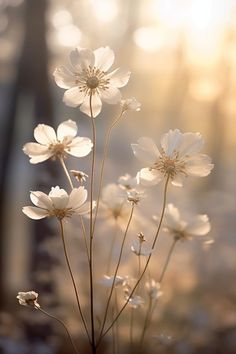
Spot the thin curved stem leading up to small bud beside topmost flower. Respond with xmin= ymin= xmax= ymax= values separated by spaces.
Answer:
xmin=93 ymin=110 xmax=124 ymax=233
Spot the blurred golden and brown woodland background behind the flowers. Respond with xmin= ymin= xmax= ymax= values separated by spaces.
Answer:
xmin=0 ymin=0 xmax=236 ymax=354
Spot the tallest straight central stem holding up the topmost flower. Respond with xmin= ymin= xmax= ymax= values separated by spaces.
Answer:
xmin=89 ymin=93 xmax=96 ymax=354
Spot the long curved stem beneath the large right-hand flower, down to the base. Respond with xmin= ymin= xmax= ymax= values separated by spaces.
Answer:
xmin=99 ymin=177 xmax=169 ymax=342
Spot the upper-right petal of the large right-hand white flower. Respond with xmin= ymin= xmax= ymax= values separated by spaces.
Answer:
xmin=178 ymin=133 xmax=204 ymax=156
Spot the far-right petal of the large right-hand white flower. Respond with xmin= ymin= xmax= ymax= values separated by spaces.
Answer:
xmin=185 ymin=154 xmax=214 ymax=177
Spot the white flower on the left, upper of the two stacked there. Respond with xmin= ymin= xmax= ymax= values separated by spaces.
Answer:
xmin=23 ymin=120 xmax=93 ymax=164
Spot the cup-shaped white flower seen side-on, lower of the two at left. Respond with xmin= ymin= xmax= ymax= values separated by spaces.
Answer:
xmin=22 ymin=186 xmax=94 ymax=220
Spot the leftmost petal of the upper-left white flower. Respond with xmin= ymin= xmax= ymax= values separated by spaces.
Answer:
xmin=23 ymin=143 xmax=53 ymax=164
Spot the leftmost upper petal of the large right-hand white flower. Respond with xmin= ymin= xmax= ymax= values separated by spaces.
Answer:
xmin=131 ymin=137 xmax=160 ymax=165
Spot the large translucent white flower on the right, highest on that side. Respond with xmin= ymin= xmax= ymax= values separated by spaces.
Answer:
xmin=131 ymin=129 xmax=213 ymax=186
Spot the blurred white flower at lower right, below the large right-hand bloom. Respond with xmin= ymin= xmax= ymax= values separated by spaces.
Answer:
xmin=164 ymin=204 xmax=211 ymax=240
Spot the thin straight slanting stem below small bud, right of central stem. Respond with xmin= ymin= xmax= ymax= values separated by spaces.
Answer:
xmin=97 ymin=204 xmax=135 ymax=345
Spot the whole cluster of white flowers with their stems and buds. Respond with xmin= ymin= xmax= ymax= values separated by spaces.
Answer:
xmin=17 ymin=47 xmax=213 ymax=353
